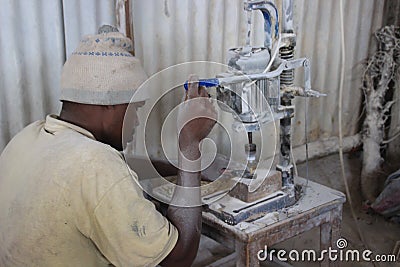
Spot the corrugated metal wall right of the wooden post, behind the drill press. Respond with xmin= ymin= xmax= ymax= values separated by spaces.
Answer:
xmin=132 ymin=0 xmax=384 ymax=159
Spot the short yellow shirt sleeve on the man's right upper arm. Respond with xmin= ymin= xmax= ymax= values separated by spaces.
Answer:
xmin=90 ymin=176 xmax=178 ymax=266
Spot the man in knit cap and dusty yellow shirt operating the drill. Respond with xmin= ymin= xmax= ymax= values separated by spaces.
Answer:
xmin=0 ymin=28 xmax=215 ymax=266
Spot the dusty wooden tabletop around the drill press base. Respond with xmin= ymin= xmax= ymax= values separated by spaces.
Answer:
xmin=203 ymin=178 xmax=346 ymax=243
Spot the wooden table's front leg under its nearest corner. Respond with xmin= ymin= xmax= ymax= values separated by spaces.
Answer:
xmin=235 ymin=240 xmax=260 ymax=267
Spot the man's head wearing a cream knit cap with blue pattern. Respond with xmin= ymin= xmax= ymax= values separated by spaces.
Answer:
xmin=60 ymin=26 xmax=147 ymax=150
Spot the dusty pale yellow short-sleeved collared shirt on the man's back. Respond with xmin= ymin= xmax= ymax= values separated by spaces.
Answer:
xmin=0 ymin=116 xmax=178 ymax=267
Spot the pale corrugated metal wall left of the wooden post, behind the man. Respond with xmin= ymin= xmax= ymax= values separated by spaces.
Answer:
xmin=0 ymin=0 xmax=116 ymax=151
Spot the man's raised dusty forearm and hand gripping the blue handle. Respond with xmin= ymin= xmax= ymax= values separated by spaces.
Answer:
xmin=161 ymin=77 xmax=216 ymax=266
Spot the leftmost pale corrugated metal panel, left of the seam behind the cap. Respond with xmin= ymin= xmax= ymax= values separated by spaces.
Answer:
xmin=0 ymin=0 xmax=65 ymax=151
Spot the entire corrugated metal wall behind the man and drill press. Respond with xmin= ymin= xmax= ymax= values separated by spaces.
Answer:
xmin=0 ymin=0 xmax=384 ymax=160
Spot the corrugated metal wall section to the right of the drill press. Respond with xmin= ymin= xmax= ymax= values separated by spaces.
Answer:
xmin=294 ymin=0 xmax=384 ymax=144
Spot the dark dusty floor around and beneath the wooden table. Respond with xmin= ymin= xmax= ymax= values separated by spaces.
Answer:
xmin=193 ymin=155 xmax=400 ymax=266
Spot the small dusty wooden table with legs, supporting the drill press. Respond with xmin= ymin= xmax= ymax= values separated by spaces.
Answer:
xmin=203 ymin=178 xmax=346 ymax=267
